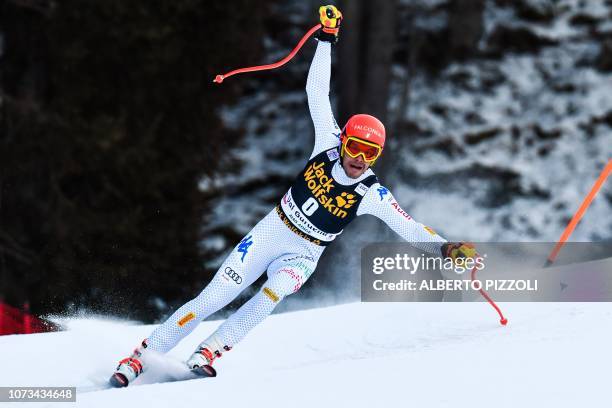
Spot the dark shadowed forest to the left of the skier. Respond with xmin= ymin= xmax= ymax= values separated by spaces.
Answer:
xmin=0 ymin=0 xmax=266 ymax=319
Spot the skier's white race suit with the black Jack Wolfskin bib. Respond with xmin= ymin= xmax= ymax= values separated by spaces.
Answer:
xmin=147 ymin=41 xmax=446 ymax=353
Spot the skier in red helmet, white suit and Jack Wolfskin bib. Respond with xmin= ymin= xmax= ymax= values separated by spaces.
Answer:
xmin=111 ymin=6 xmax=475 ymax=386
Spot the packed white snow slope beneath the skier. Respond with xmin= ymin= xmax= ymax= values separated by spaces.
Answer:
xmin=0 ymin=303 xmax=612 ymax=408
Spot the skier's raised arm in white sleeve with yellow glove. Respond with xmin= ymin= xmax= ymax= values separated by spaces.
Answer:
xmin=306 ymin=6 xmax=342 ymax=157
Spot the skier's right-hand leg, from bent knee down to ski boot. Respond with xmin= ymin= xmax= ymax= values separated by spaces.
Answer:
xmin=187 ymin=254 xmax=316 ymax=367
